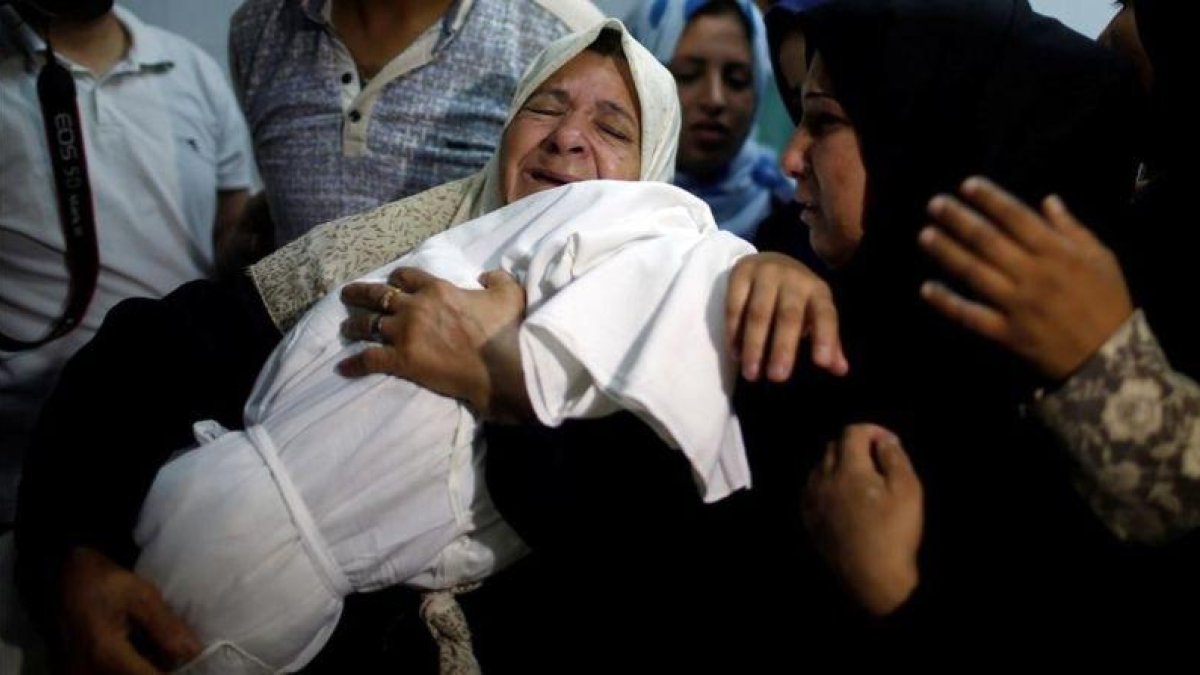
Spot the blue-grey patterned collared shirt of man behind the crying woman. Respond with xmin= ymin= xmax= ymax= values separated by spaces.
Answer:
xmin=229 ymin=0 xmax=600 ymax=241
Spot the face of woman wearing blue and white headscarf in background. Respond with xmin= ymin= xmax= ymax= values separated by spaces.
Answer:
xmin=670 ymin=14 xmax=755 ymax=177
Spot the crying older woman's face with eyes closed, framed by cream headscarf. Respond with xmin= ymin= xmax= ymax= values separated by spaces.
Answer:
xmin=500 ymin=50 xmax=642 ymax=204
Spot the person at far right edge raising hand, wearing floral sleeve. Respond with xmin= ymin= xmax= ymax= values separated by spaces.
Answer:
xmin=922 ymin=0 xmax=1200 ymax=566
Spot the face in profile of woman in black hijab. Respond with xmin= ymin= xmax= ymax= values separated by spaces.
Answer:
xmin=779 ymin=38 xmax=866 ymax=268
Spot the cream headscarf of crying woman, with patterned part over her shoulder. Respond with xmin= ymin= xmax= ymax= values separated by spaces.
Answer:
xmin=250 ymin=19 xmax=680 ymax=330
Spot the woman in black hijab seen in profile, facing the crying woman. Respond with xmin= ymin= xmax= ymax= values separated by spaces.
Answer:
xmin=740 ymin=0 xmax=1152 ymax=643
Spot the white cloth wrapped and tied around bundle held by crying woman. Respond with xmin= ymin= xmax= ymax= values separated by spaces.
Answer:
xmin=134 ymin=181 xmax=752 ymax=670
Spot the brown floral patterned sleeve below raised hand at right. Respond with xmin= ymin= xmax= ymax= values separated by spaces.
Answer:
xmin=1034 ymin=311 xmax=1200 ymax=542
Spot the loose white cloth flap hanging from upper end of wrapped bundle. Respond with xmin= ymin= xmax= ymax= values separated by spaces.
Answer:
xmin=520 ymin=186 xmax=754 ymax=502
